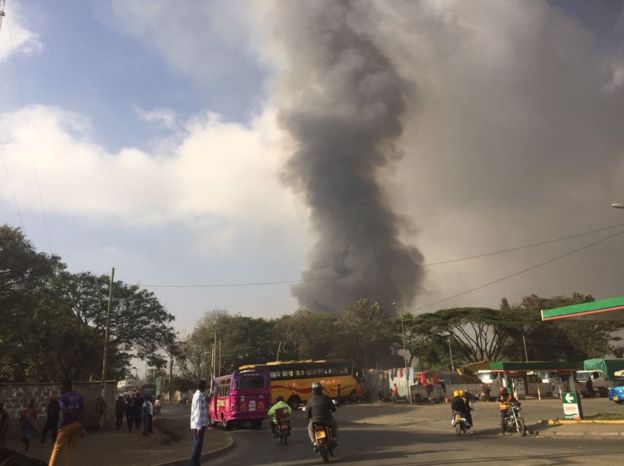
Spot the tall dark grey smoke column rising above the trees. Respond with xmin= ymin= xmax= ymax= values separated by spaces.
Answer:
xmin=268 ymin=1 xmax=423 ymax=311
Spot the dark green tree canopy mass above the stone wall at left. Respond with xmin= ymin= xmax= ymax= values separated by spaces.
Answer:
xmin=0 ymin=225 xmax=175 ymax=381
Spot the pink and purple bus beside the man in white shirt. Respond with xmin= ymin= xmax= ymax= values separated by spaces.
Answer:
xmin=209 ymin=368 xmax=271 ymax=429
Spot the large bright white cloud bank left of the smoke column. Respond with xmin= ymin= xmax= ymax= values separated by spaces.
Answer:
xmin=0 ymin=106 xmax=302 ymax=253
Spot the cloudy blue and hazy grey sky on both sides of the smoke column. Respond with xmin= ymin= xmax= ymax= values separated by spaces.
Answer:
xmin=0 ymin=0 xmax=624 ymax=331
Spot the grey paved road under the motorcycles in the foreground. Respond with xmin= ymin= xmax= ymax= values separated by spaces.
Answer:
xmin=206 ymin=400 xmax=624 ymax=466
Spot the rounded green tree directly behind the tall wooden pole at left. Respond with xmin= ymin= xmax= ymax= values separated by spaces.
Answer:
xmin=49 ymin=272 xmax=175 ymax=378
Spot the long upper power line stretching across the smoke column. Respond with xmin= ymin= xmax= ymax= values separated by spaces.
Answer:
xmin=143 ymin=223 xmax=624 ymax=288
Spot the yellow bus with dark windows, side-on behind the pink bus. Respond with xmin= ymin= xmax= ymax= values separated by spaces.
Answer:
xmin=240 ymin=359 xmax=363 ymax=409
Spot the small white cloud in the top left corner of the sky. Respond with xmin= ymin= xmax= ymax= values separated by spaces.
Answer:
xmin=0 ymin=2 xmax=43 ymax=62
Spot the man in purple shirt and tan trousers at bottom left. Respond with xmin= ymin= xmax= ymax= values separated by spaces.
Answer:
xmin=48 ymin=381 xmax=85 ymax=466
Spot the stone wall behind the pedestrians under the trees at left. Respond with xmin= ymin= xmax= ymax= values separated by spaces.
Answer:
xmin=0 ymin=381 xmax=117 ymax=435
